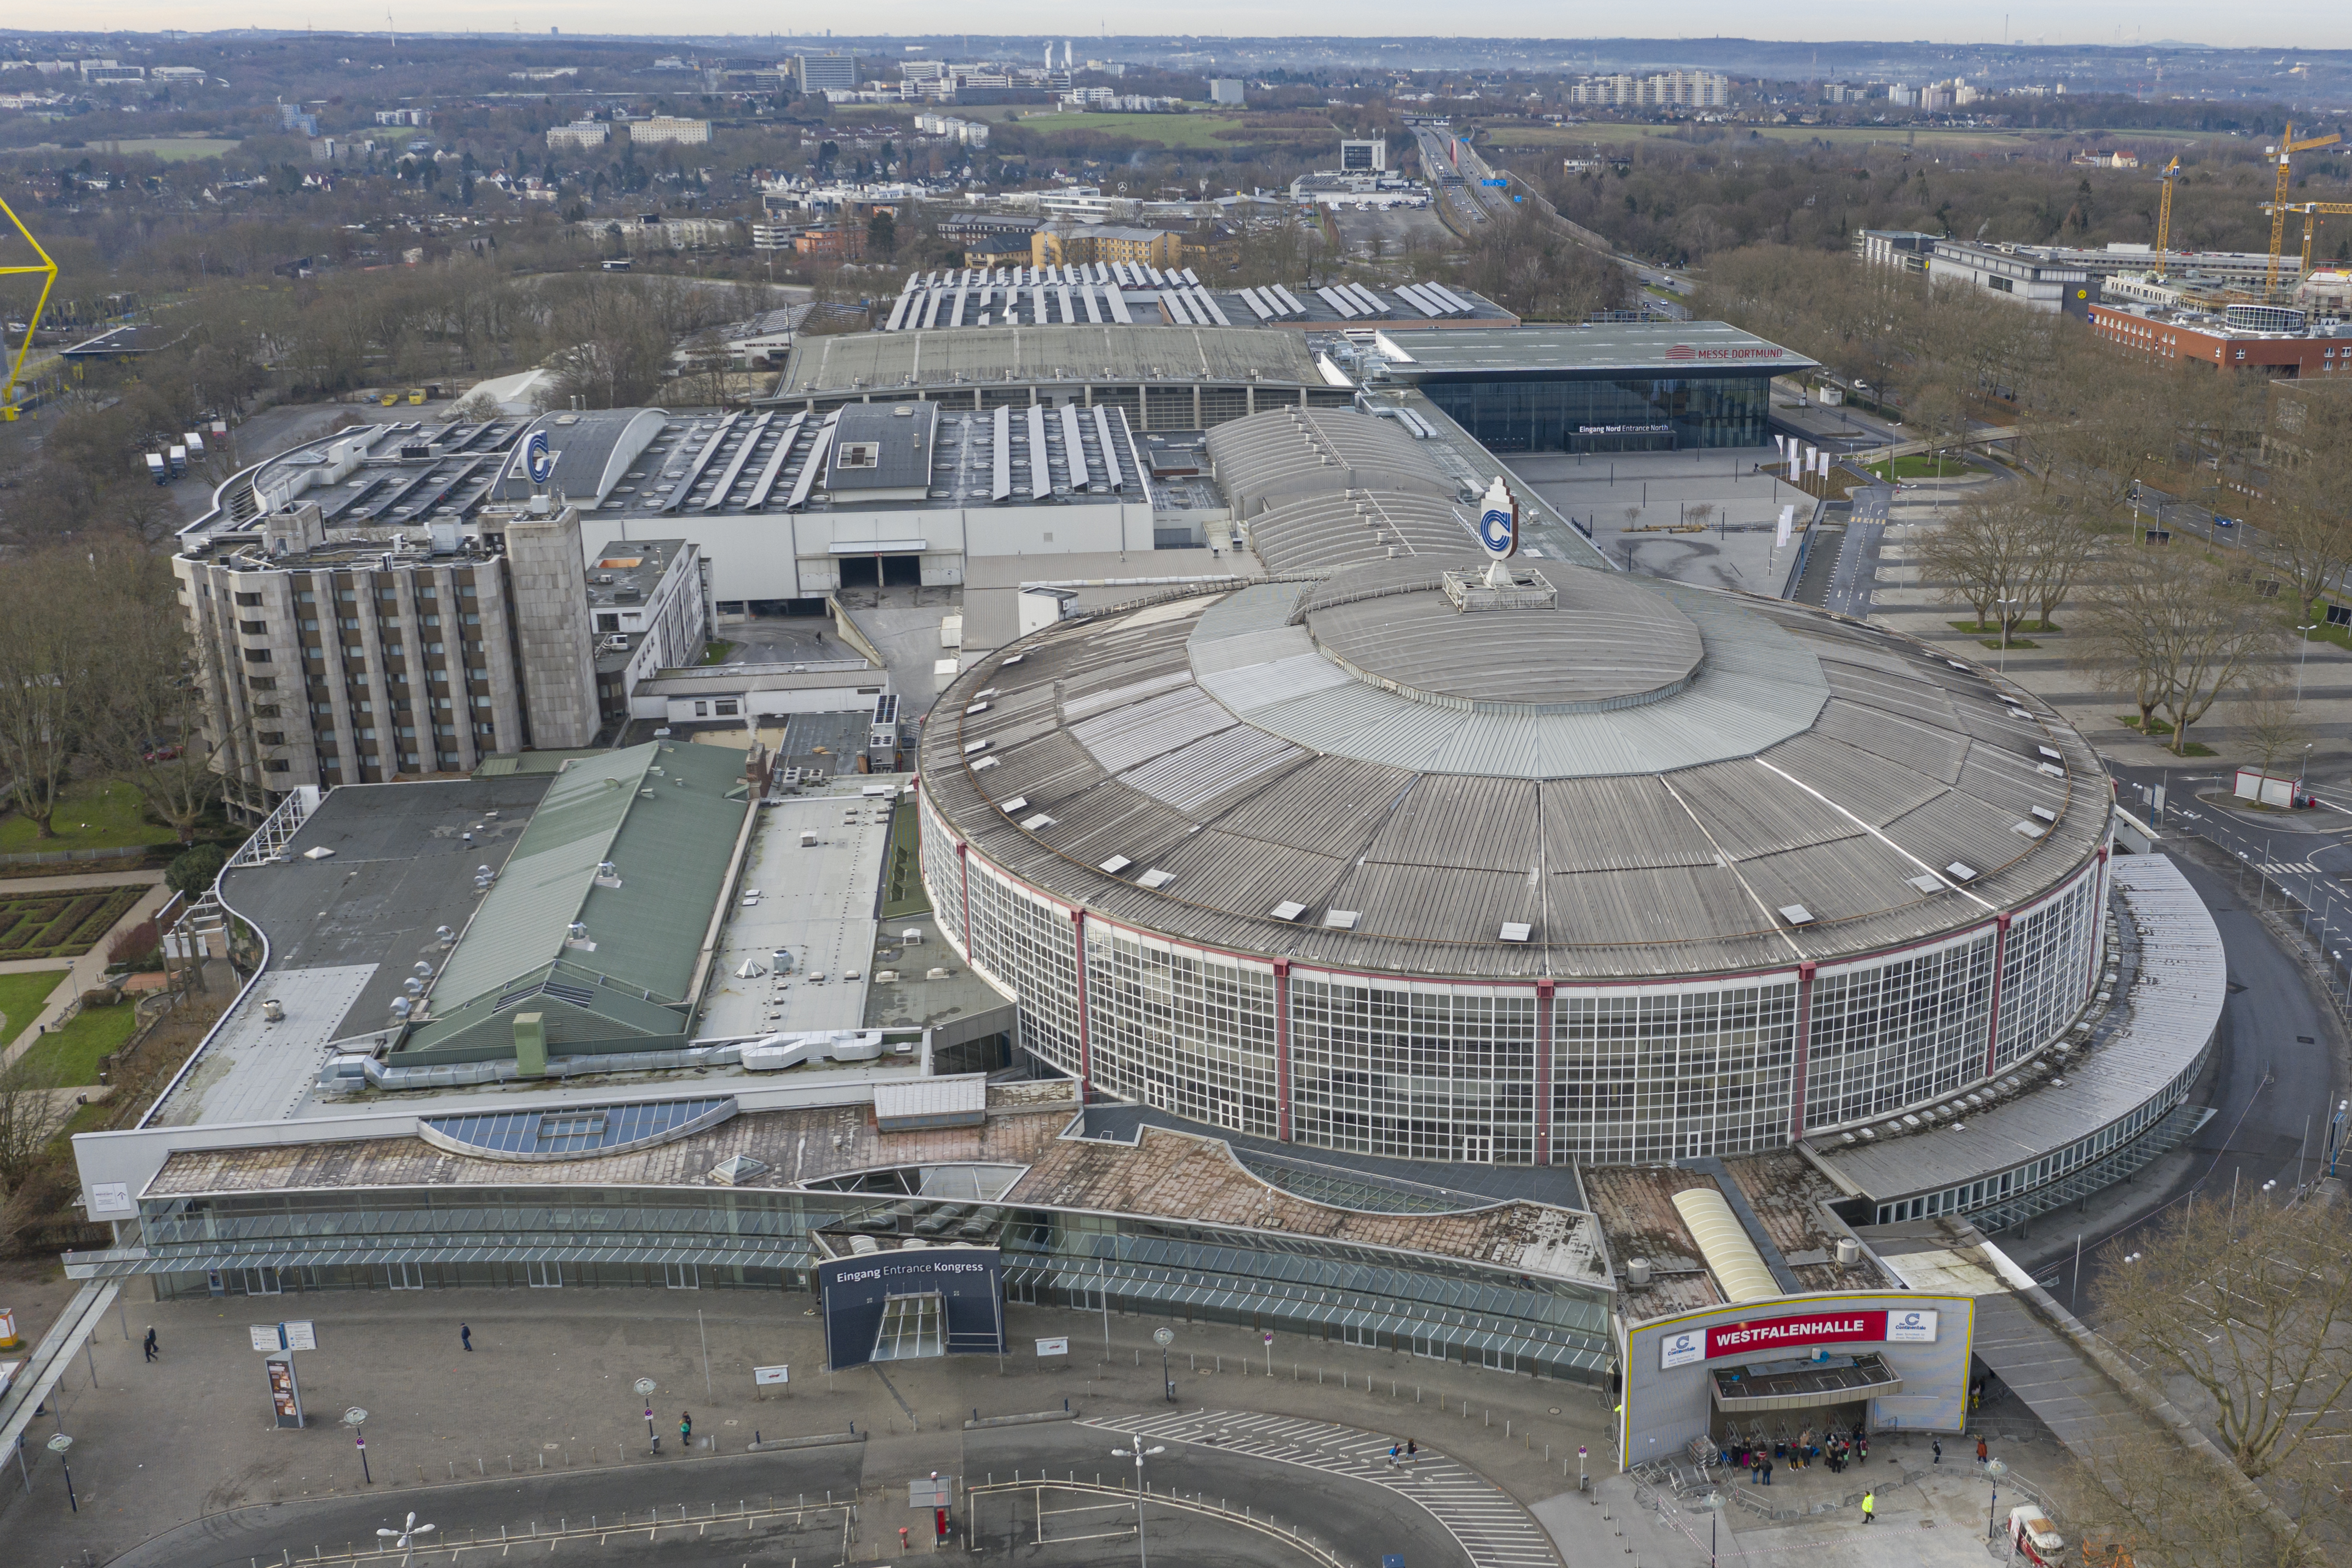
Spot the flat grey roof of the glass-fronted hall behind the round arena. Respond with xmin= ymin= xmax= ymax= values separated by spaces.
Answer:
xmin=1378 ymin=322 xmax=1821 ymax=381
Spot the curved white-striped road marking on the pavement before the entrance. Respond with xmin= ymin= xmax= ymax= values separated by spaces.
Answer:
xmin=1085 ymin=1410 xmax=1559 ymax=1568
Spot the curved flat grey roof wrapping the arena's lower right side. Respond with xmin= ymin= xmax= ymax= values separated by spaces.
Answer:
xmin=1806 ymin=855 xmax=2230 ymax=1201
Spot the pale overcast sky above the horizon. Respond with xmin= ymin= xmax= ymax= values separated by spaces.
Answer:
xmin=68 ymin=0 xmax=2352 ymax=56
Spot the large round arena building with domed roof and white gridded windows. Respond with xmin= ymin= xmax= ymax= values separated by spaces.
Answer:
xmin=922 ymin=491 xmax=2112 ymax=1164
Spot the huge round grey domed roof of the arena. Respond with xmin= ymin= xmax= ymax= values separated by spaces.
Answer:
xmin=922 ymin=553 xmax=2110 ymax=978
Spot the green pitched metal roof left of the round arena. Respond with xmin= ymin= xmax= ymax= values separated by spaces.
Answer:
xmin=402 ymin=740 xmax=753 ymax=1055
